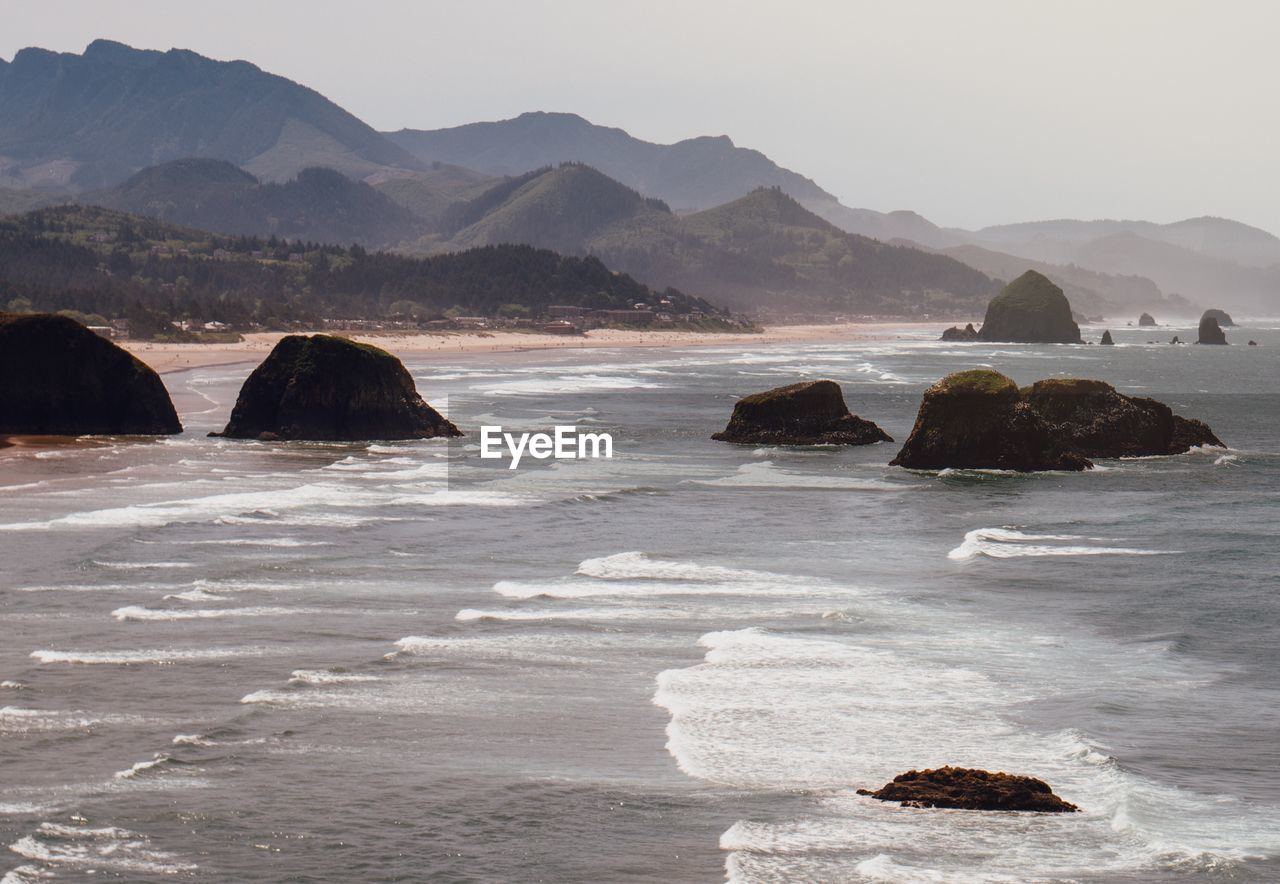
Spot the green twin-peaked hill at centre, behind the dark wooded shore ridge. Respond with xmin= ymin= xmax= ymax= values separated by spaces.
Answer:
xmin=417 ymin=164 xmax=997 ymax=315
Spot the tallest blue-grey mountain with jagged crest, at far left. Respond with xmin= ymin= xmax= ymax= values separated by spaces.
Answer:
xmin=0 ymin=40 xmax=421 ymax=191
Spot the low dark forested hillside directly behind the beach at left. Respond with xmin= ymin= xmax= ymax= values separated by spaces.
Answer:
xmin=0 ymin=206 xmax=718 ymax=331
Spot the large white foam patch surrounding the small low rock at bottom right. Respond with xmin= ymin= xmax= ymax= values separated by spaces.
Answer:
xmin=654 ymin=628 xmax=1280 ymax=881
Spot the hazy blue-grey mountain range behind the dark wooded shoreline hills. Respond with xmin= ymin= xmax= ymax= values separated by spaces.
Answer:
xmin=0 ymin=41 xmax=1280 ymax=315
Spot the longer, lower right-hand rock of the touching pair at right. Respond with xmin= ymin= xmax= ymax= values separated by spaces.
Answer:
xmin=1021 ymin=377 xmax=1222 ymax=458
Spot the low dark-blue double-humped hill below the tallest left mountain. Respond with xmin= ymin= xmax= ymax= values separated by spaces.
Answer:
xmin=96 ymin=159 xmax=426 ymax=247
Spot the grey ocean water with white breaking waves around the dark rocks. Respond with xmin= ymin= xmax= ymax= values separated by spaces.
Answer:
xmin=0 ymin=322 xmax=1280 ymax=884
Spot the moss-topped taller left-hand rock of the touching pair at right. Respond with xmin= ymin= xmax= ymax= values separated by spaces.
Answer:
xmin=891 ymin=368 xmax=1093 ymax=472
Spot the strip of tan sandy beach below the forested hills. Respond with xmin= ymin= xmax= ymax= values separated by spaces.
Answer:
xmin=122 ymin=322 xmax=945 ymax=374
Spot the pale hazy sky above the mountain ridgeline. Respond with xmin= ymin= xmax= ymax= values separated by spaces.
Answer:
xmin=0 ymin=0 xmax=1280 ymax=233
